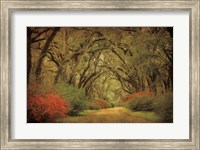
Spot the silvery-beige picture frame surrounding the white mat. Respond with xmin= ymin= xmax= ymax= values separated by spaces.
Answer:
xmin=0 ymin=0 xmax=200 ymax=150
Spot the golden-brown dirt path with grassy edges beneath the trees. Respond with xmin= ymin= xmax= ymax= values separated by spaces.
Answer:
xmin=59 ymin=107 xmax=161 ymax=123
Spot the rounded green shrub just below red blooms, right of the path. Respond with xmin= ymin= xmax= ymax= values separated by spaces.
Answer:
xmin=129 ymin=96 xmax=153 ymax=111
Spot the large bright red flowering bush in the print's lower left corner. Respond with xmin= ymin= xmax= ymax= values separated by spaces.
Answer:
xmin=27 ymin=94 xmax=69 ymax=123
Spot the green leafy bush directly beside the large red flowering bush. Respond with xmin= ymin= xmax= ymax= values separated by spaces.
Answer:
xmin=56 ymin=84 xmax=88 ymax=115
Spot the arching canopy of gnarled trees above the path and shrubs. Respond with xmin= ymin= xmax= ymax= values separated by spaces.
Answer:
xmin=27 ymin=27 xmax=173 ymax=100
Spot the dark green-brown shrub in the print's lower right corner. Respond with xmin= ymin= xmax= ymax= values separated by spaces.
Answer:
xmin=153 ymin=93 xmax=173 ymax=122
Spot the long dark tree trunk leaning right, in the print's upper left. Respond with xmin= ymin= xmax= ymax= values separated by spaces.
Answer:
xmin=35 ymin=27 xmax=60 ymax=83
